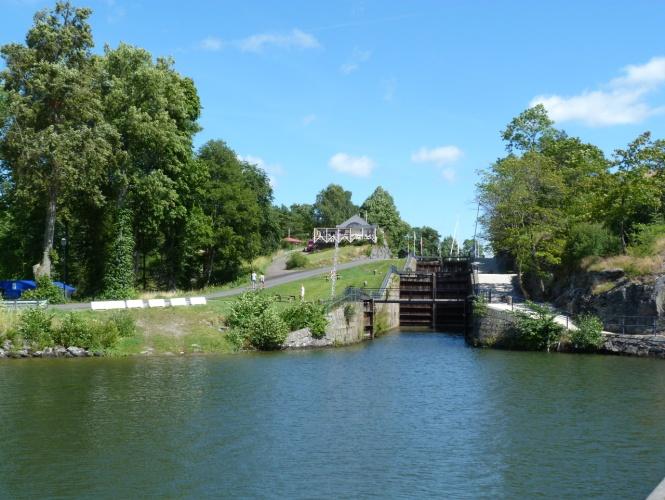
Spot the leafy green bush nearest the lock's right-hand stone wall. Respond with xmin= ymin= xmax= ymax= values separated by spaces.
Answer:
xmin=515 ymin=302 xmax=563 ymax=352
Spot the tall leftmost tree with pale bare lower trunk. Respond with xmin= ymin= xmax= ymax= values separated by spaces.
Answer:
xmin=0 ymin=2 xmax=118 ymax=277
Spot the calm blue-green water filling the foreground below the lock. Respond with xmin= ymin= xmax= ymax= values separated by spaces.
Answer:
xmin=0 ymin=333 xmax=665 ymax=499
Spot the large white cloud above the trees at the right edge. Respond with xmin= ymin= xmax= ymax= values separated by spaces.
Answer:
xmin=530 ymin=57 xmax=665 ymax=127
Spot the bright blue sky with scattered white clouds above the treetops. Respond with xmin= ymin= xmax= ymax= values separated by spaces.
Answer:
xmin=0 ymin=0 xmax=665 ymax=239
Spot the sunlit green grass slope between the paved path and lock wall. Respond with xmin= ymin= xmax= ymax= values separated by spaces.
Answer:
xmin=266 ymin=259 xmax=404 ymax=301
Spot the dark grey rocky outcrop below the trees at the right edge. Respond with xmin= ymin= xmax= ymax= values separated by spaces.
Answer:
xmin=552 ymin=269 xmax=665 ymax=333
